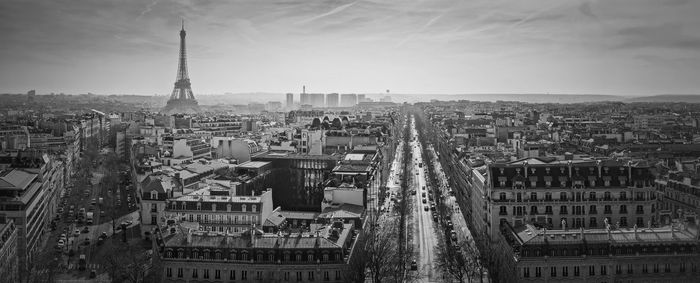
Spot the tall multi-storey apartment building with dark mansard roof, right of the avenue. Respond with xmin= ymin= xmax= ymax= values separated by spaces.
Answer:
xmin=484 ymin=158 xmax=657 ymax=242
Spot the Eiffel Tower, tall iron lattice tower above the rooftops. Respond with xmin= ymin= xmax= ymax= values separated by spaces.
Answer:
xmin=161 ymin=20 xmax=199 ymax=114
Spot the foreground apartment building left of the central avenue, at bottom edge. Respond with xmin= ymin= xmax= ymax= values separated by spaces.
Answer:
xmin=154 ymin=222 xmax=355 ymax=282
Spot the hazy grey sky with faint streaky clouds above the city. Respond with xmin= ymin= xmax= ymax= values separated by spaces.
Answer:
xmin=0 ymin=0 xmax=700 ymax=95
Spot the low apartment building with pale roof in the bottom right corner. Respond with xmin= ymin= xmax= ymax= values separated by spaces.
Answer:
xmin=492 ymin=223 xmax=700 ymax=282
